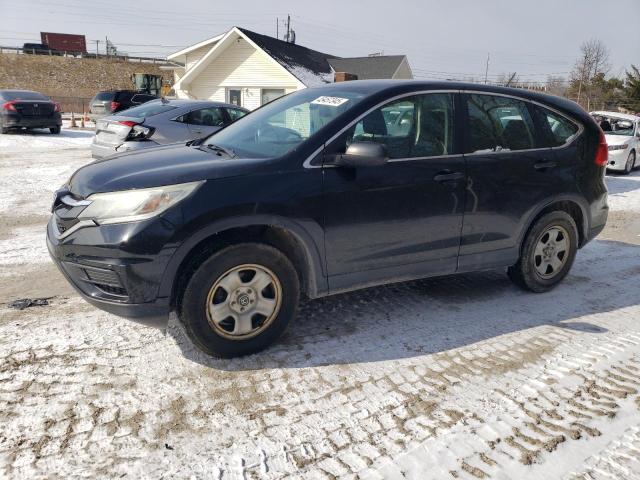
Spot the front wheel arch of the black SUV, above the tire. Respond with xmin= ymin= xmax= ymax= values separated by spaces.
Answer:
xmin=159 ymin=216 xmax=328 ymax=307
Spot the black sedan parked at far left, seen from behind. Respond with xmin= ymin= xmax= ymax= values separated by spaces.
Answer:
xmin=0 ymin=90 xmax=62 ymax=133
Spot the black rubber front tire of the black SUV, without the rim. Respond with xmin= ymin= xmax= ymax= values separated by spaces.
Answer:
xmin=179 ymin=243 xmax=300 ymax=358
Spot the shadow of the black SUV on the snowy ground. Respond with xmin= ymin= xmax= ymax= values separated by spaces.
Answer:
xmin=168 ymin=241 xmax=640 ymax=370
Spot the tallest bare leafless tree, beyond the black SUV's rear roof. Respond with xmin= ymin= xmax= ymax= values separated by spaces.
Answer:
xmin=570 ymin=38 xmax=611 ymax=109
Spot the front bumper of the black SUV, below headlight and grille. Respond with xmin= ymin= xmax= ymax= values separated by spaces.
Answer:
xmin=47 ymin=215 xmax=173 ymax=328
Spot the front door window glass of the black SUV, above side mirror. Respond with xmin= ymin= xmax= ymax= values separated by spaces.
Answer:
xmin=338 ymin=93 xmax=453 ymax=159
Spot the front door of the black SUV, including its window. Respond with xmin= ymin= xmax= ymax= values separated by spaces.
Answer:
xmin=324 ymin=94 xmax=465 ymax=290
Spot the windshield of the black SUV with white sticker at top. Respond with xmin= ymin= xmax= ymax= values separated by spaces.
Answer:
xmin=204 ymin=88 xmax=365 ymax=158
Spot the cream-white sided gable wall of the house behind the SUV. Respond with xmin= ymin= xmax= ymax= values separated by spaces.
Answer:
xmin=186 ymin=39 xmax=297 ymax=109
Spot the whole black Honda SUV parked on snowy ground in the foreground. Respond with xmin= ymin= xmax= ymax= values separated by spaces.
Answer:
xmin=47 ymin=81 xmax=608 ymax=356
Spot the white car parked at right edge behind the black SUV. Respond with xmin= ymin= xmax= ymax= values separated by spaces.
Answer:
xmin=591 ymin=112 xmax=640 ymax=174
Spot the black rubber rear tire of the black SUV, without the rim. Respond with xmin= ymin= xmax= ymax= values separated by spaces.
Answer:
xmin=507 ymin=211 xmax=578 ymax=293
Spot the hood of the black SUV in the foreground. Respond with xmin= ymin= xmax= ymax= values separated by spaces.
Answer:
xmin=68 ymin=144 xmax=269 ymax=198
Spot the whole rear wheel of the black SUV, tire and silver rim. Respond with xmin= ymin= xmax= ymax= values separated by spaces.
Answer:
xmin=507 ymin=211 xmax=578 ymax=293
